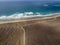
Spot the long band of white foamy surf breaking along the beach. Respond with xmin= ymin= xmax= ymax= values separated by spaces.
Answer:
xmin=0 ymin=12 xmax=60 ymax=20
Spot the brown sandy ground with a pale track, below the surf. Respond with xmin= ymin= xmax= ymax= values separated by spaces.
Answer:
xmin=0 ymin=16 xmax=60 ymax=45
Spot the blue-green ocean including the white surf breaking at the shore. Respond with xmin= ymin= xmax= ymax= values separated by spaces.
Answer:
xmin=0 ymin=1 xmax=60 ymax=20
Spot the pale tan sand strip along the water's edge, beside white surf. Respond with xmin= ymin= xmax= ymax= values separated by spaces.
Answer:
xmin=0 ymin=14 xmax=60 ymax=24
